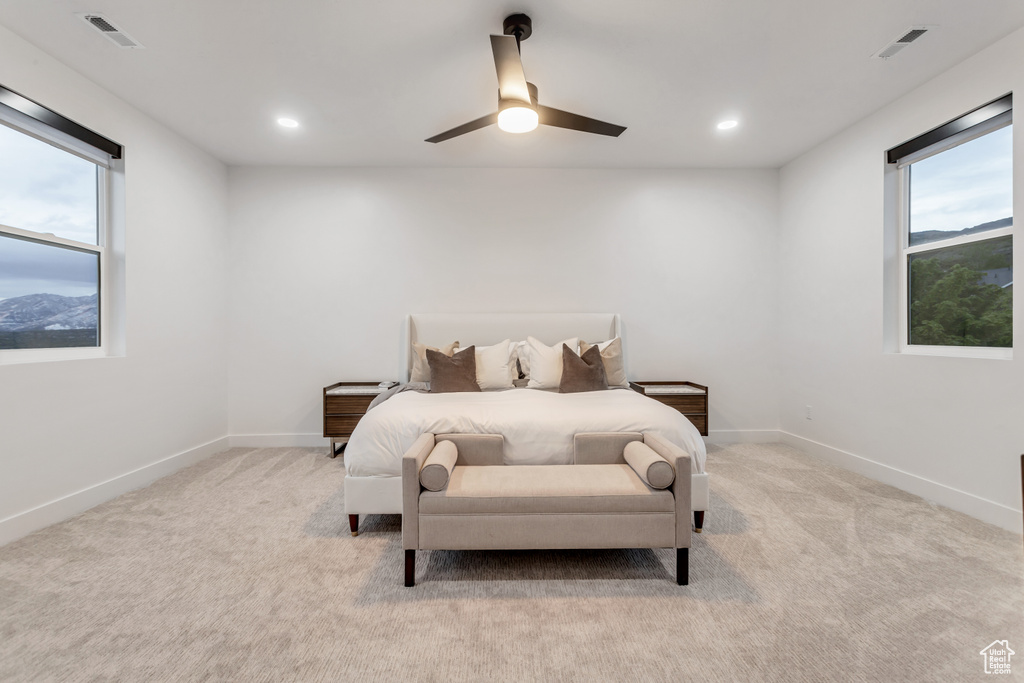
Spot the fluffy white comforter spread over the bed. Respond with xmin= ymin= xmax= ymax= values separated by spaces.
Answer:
xmin=345 ymin=389 xmax=707 ymax=477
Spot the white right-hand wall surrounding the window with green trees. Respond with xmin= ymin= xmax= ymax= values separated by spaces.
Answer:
xmin=779 ymin=26 xmax=1024 ymax=529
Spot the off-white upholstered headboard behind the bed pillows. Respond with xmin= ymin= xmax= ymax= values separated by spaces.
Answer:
xmin=398 ymin=313 xmax=622 ymax=382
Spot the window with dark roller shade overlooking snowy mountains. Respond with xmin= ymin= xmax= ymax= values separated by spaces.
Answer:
xmin=0 ymin=87 xmax=120 ymax=357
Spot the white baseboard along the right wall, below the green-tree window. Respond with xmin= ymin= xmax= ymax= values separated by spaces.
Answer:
xmin=779 ymin=431 xmax=1022 ymax=533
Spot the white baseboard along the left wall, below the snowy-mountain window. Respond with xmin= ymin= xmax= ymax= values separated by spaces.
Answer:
xmin=0 ymin=436 xmax=228 ymax=546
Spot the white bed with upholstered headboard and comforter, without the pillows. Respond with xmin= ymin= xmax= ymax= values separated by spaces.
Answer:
xmin=345 ymin=313 xmax=709 ymax=533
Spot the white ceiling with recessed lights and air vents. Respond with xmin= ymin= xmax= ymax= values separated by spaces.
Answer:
xmin=0 ymin=0 xmax=1024 ymax=168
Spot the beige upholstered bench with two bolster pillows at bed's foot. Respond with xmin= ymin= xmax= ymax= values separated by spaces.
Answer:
xmin=401 ymin=432 xmax=690 ymax=586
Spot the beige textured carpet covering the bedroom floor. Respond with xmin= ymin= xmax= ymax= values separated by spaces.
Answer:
xmin=0 ymin=444 xmax=1024 ymax=683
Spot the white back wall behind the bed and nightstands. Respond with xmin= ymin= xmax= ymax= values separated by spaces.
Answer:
xmin=228 ymin=168 xmax=777 ymax=444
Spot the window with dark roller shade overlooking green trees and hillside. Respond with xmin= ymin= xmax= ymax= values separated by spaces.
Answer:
xmin=889 ymin=95 xmax=1014 ymax=356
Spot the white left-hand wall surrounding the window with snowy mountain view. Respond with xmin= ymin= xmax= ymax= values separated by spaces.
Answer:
xmin=0 ymin=28 xmax=227 ymax=544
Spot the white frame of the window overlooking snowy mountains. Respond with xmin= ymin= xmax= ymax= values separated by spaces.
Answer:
xmin=0 ymin=110 xmax=116 ymax=366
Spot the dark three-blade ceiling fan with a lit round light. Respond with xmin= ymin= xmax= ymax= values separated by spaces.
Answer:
xmin=426 ymin=14 xmax=626 ymax=142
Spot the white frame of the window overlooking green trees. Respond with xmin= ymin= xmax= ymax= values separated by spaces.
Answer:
xmin=897 ymin=110 xmax=1016 ymax=360
